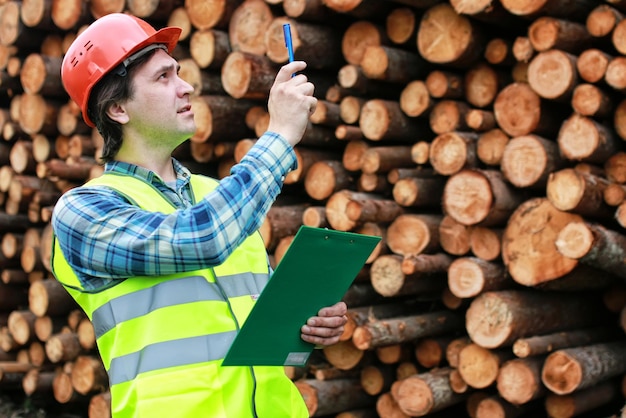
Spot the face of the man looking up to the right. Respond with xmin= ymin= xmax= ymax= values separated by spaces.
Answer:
xmin=124 ymin=50 xmax=196 ymax=146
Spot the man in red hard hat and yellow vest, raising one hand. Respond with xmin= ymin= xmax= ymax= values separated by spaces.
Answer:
xmin=52 ymin=13 xmax=346 ymax=418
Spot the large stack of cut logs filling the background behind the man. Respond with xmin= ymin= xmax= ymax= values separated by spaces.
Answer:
xmin=0 ymin=0 xmax=626 ymax=418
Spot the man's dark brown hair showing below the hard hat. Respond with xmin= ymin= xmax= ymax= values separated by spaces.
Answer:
xmin=87 ymin=49 xmax=155 ymax=163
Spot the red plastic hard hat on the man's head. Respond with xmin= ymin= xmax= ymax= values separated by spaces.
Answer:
xmin=61 ymin=13 xmax=182 ymax=128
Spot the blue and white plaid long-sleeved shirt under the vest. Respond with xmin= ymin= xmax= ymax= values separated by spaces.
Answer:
xmin=52 ymin=133 xmax=297 ymax=290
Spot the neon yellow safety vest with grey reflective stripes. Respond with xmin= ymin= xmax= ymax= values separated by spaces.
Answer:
xmin=52 ymin=173 xmax=308 ymax=418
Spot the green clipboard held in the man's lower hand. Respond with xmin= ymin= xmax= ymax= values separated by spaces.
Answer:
xmin=222 ymin=226 xmax=381 ymax=366
